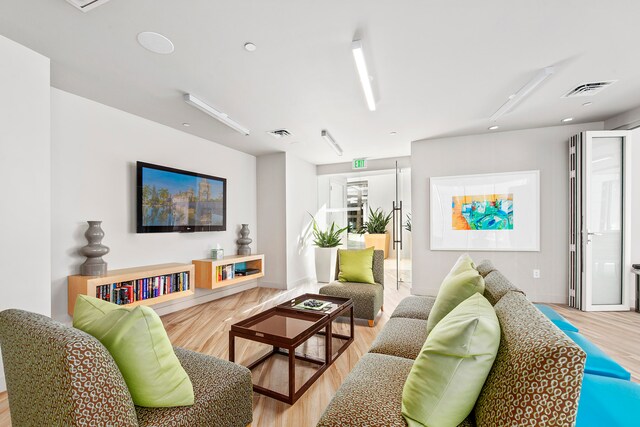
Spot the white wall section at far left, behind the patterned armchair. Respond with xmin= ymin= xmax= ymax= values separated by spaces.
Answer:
xmin=0 ymin=36 xmax=51 ymax=391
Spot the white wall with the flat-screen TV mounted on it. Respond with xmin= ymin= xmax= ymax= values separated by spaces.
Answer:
xmin=50 ymin=89 xmax=257 ymax=321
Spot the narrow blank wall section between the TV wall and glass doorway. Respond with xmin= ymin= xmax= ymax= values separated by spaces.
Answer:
xmin=256 ymin=153 xmax=287 ymax=289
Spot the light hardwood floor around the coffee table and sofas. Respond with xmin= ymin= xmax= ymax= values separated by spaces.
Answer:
xmin=0 ymin=285 xmax=640 ymax=427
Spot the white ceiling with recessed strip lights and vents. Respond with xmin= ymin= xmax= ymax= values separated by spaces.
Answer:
xmin=0 ymin=0 xmax=640 ymax=164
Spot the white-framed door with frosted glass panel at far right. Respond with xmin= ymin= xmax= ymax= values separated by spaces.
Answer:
xmin=580 ymin=131 xmax=631 ymax=311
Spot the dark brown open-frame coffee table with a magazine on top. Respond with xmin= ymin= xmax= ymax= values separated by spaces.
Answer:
xmin=229 ymin=294 xmax=354 ymax=404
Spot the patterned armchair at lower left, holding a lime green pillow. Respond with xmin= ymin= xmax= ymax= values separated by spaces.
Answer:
xmin=0 ymin=309 xmax=252 ymax=427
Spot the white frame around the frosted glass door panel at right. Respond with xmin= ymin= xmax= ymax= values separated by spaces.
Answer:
xmin=580 ymin=130 xmax=631 ymax=311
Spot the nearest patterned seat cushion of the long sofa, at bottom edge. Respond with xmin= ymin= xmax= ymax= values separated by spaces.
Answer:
xmin=316 ymin=353 xmax=473 ymax=427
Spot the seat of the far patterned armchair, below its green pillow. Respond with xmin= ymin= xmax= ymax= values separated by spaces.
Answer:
xmin=318 ymin=282 xmax=384 ymax=320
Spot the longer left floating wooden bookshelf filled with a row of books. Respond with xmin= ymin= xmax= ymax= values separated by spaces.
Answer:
xmin=68 ymin=263 xmax=195 ymax=315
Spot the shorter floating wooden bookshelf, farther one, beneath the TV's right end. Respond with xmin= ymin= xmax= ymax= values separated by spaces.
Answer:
xmin=192 ymin=254 xmax=264 ymax=289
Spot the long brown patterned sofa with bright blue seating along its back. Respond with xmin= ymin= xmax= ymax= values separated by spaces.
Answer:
xmin=318 ymin=261 xmax=640 ymax=427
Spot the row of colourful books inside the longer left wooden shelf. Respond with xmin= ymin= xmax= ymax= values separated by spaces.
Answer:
xmin=96 ymin=271 xmax=189 ymax=305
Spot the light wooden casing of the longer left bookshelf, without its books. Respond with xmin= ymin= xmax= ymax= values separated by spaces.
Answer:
xmin=67 ymin=263 xmax=195 ymax=316
